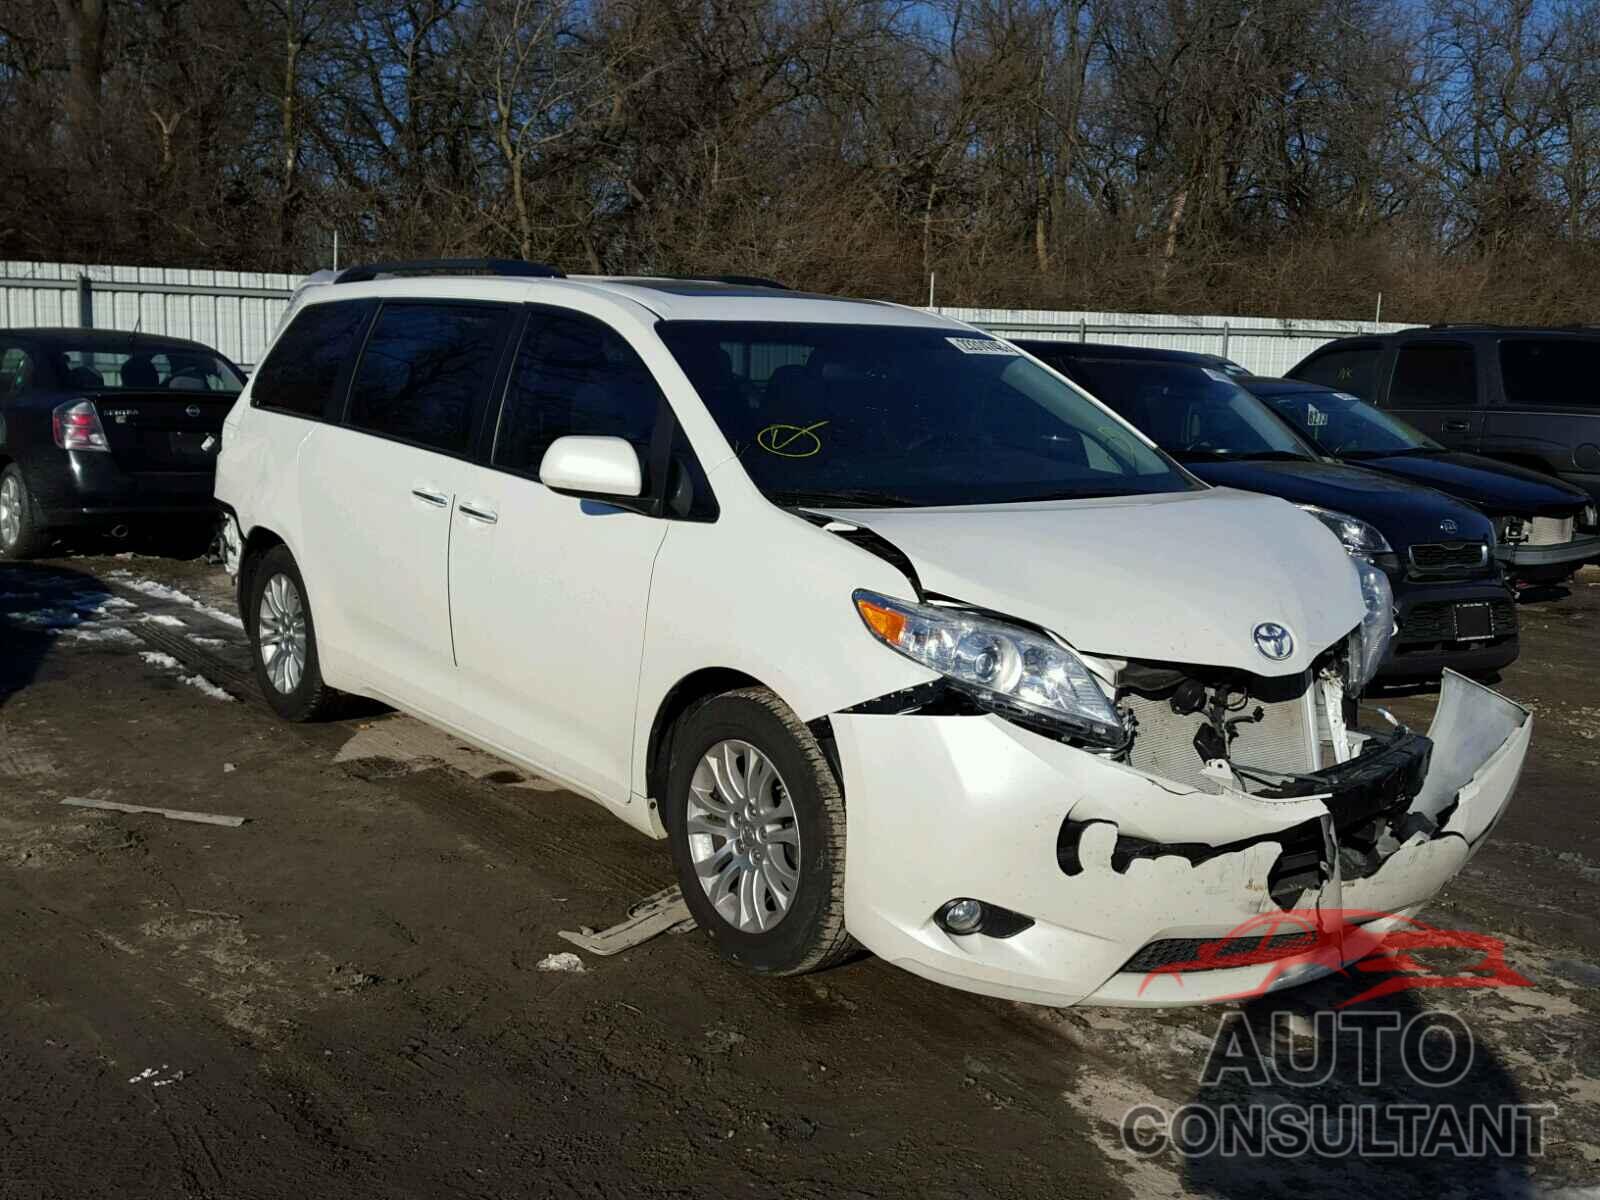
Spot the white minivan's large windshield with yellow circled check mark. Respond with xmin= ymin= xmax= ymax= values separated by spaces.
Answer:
xmin=658 ymin=322 xmax=1197 ymax=506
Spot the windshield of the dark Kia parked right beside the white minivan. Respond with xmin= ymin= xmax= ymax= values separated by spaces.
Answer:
xmin=1072 ymin=358 xmax=1315 ymax=461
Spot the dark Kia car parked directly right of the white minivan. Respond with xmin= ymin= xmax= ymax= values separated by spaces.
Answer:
xmin=1018 ymin=341 xmax=1518 ymax=682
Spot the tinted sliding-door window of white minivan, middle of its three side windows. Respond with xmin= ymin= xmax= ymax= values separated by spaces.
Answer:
xmin=349 ymin=302 xmax=507 ymax=454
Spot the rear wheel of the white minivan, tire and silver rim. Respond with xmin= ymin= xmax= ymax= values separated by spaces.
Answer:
xmin=245 ymin=546 xmax=339 ymax=722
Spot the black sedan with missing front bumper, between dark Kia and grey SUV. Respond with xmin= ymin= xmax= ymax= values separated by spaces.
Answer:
xmin=1238 ymin=378 xmax=1600 ymax=584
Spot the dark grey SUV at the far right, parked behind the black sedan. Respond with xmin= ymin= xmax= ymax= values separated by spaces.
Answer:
xmin=1288 ymin=325 xmax=1600 ymax=498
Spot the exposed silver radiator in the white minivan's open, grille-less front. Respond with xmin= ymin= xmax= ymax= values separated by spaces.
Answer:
xmin=1123 ymin=675 xmax=1318 ymax=790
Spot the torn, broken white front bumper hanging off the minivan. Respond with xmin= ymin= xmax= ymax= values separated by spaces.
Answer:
xmin=830 ymin=672 xmax=1533 ymax=1006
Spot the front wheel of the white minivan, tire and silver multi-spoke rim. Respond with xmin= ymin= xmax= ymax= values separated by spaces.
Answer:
xmin=662 ymin=688 xmax=854 ymax=974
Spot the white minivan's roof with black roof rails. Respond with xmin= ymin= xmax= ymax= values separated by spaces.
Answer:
xmin=304 ymin=274 xmax=970 ymax=331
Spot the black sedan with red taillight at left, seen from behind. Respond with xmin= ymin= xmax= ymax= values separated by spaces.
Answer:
xmin=0 ymin=330 xmax=245 ymax=558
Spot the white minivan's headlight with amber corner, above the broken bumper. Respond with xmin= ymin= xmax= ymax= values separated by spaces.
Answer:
xmin=853 ymin=590 xmax=1126 ymax=746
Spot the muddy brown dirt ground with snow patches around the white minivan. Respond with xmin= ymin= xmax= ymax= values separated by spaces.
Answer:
xmin=0 ymin=555 xmax=1600 ymax=1200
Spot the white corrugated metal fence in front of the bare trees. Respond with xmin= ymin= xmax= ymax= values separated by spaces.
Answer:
xmin=0 ymin=262 xmax=1405 ymax=374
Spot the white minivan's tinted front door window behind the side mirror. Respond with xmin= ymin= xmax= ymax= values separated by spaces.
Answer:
xmin=494 ymin=314 xmax=662 ymax=493
